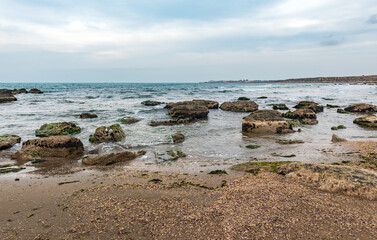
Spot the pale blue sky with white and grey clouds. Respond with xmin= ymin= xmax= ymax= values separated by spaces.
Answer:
xmin=0 ymin=0 xmax=377 ymax=82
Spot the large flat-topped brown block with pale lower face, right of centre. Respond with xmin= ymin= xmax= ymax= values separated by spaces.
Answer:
xmin=242 ymin=110 xmax=293 ymax=133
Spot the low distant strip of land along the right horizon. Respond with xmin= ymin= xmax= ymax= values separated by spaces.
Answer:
xmin=206 ymin=75 xmax=377 ymax=84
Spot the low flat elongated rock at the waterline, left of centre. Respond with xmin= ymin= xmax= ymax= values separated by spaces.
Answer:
xmin=82 ymin=151 xmax=146 ymax=166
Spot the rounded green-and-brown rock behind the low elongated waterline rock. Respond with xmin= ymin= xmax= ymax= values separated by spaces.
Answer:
xmin=89 ymin=124 xmax=126 ymax=143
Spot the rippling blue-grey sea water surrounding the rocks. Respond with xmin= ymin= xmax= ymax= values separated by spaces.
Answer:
xmin=0 ymin=83 xmax=377 ymax=170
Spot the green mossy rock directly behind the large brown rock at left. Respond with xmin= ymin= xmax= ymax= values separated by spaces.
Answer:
xmin=35 ymin=122 xmax=81 ymax=137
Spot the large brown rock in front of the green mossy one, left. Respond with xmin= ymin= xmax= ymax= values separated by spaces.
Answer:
xmin=12 ymin=136 xmax=84 ymax=161
